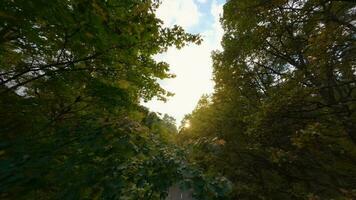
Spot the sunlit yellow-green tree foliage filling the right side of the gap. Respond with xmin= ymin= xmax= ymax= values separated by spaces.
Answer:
xmin=180 ymin=0 xmax=356 ymax=199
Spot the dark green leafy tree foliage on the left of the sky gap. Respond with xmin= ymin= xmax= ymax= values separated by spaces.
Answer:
xmin=0 ymin=0 xmax=228 ymax=199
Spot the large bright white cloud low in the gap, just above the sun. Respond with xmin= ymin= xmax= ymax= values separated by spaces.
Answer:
xmin=146 ymin=43 xmax=213 ymax=123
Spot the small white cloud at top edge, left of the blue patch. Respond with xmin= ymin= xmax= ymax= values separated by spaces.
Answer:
xmin=156 ymin=0 xmax=201 ymax=29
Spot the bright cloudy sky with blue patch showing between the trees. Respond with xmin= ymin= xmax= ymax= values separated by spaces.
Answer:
xmin=143 ymin=0 xmax=225 ymax=126
